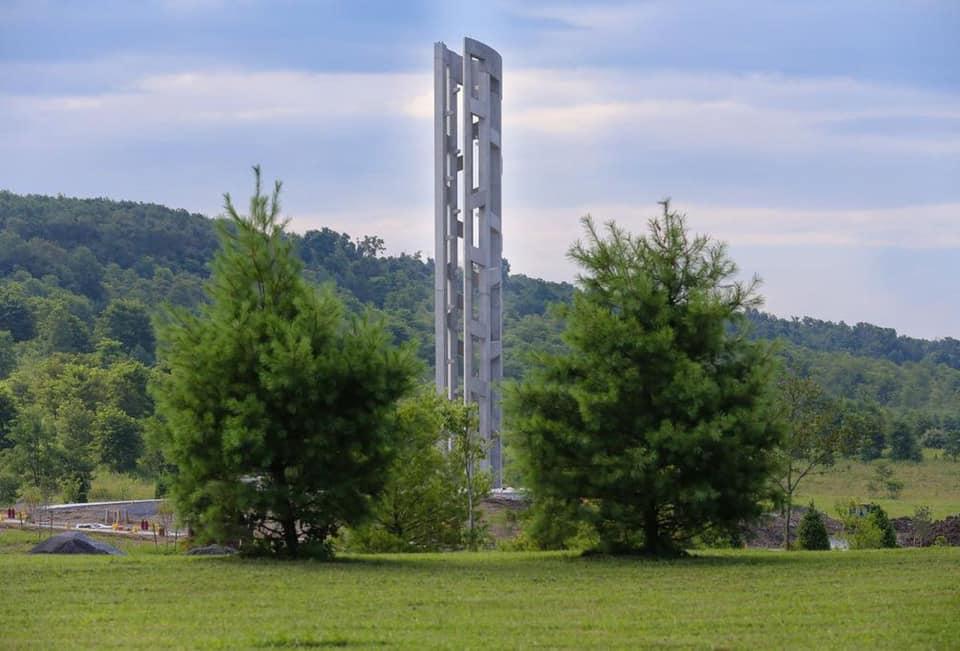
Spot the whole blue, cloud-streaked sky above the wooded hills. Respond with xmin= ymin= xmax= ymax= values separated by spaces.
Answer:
xmin=0 ymin=0 xmax=960 ymax=338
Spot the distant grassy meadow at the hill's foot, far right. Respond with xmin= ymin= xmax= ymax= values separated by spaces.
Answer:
xmin=796 ymin=450 xmax=960 ymax=519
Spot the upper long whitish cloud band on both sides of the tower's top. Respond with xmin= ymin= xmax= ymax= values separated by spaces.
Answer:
xmin=0 ymin=62 xmax=960 ymax=155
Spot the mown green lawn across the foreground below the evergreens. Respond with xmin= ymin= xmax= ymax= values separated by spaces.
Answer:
xmin=0 ymin=531 xmax=960 ymax=649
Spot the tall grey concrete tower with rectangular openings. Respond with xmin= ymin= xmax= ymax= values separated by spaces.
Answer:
xmin=433 ymin=38 xmax=503 ymax=488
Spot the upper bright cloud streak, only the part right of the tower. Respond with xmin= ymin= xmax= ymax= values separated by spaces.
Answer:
xmin=504 ymin=70 xmax=960 ymax=154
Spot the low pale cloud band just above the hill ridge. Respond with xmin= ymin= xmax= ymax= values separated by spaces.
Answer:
xmin=280 ymin=203 xmax=960 ymax=290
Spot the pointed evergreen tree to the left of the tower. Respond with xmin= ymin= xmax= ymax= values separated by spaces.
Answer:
xmin=156 ymin=168 xmax=416 ymax=556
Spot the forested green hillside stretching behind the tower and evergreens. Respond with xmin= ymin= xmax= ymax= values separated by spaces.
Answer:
xmin=0 ymin=192 xmax=960 ymax=501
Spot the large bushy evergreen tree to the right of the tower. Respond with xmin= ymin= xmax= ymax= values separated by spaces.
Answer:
xmin=509 ymin=209 xmax=780 ymax=555
